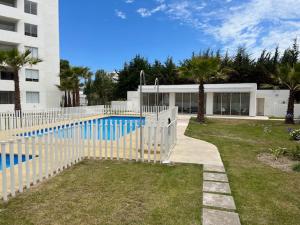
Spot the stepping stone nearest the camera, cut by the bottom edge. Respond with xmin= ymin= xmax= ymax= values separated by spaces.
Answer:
xmin=202 ymin=209 xmax=241 ymax=225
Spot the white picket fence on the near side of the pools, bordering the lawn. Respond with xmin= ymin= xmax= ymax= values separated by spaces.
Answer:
xmin=0 ymin=107 xmax=178 ymax=201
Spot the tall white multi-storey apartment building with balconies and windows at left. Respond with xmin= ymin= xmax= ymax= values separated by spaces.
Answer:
xmin=0 ymin=0 xmax=61 ymax=112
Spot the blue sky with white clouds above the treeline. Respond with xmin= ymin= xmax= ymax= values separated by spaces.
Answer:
xmin=60 ymin=0 xmax=300 ymax=71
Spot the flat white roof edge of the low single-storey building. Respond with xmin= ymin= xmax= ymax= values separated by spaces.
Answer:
xmin=138 ymin=83 xmax=257 ymax=93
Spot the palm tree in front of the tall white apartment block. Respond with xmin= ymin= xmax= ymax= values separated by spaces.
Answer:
xmin=0 ymin=49 xmax=42 ymax=111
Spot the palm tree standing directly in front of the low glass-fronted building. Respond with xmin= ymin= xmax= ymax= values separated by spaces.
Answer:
xmin=179 ymin=50 xmax=220 ymax=123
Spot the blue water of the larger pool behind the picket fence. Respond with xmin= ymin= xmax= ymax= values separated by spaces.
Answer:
xmin=20 ymin=116 xmax=145 ymax=140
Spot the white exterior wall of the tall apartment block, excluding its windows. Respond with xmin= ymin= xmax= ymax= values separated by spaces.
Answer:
xmin=0 ymin=0 xmax=61 ymax=111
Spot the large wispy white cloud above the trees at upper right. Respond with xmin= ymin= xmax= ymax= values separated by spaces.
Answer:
xmin=207 ymin=0 xmax=300 ymax=56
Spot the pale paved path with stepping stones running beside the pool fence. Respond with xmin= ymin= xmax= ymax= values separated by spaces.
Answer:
xmin=170 ymin=116 xmax=241 ymax=225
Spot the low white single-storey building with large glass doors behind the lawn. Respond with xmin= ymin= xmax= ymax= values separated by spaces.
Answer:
xmin=127 ymin=83 xmax=300 ymax=117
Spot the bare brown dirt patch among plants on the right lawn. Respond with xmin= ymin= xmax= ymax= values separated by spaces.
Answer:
xmin=257 ymin=153 xmax=298 ymax=172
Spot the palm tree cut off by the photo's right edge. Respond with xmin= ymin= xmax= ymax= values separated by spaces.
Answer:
xmin=275 ymin=63 xmax=300 ymax=124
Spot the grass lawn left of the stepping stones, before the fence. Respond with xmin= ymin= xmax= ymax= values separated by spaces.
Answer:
xmin=0 ymin=161 xmax=202 ymax=225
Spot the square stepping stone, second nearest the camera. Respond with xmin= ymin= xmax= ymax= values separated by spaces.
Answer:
xmin=203 ymin=193 xmax=236 ymax=210
